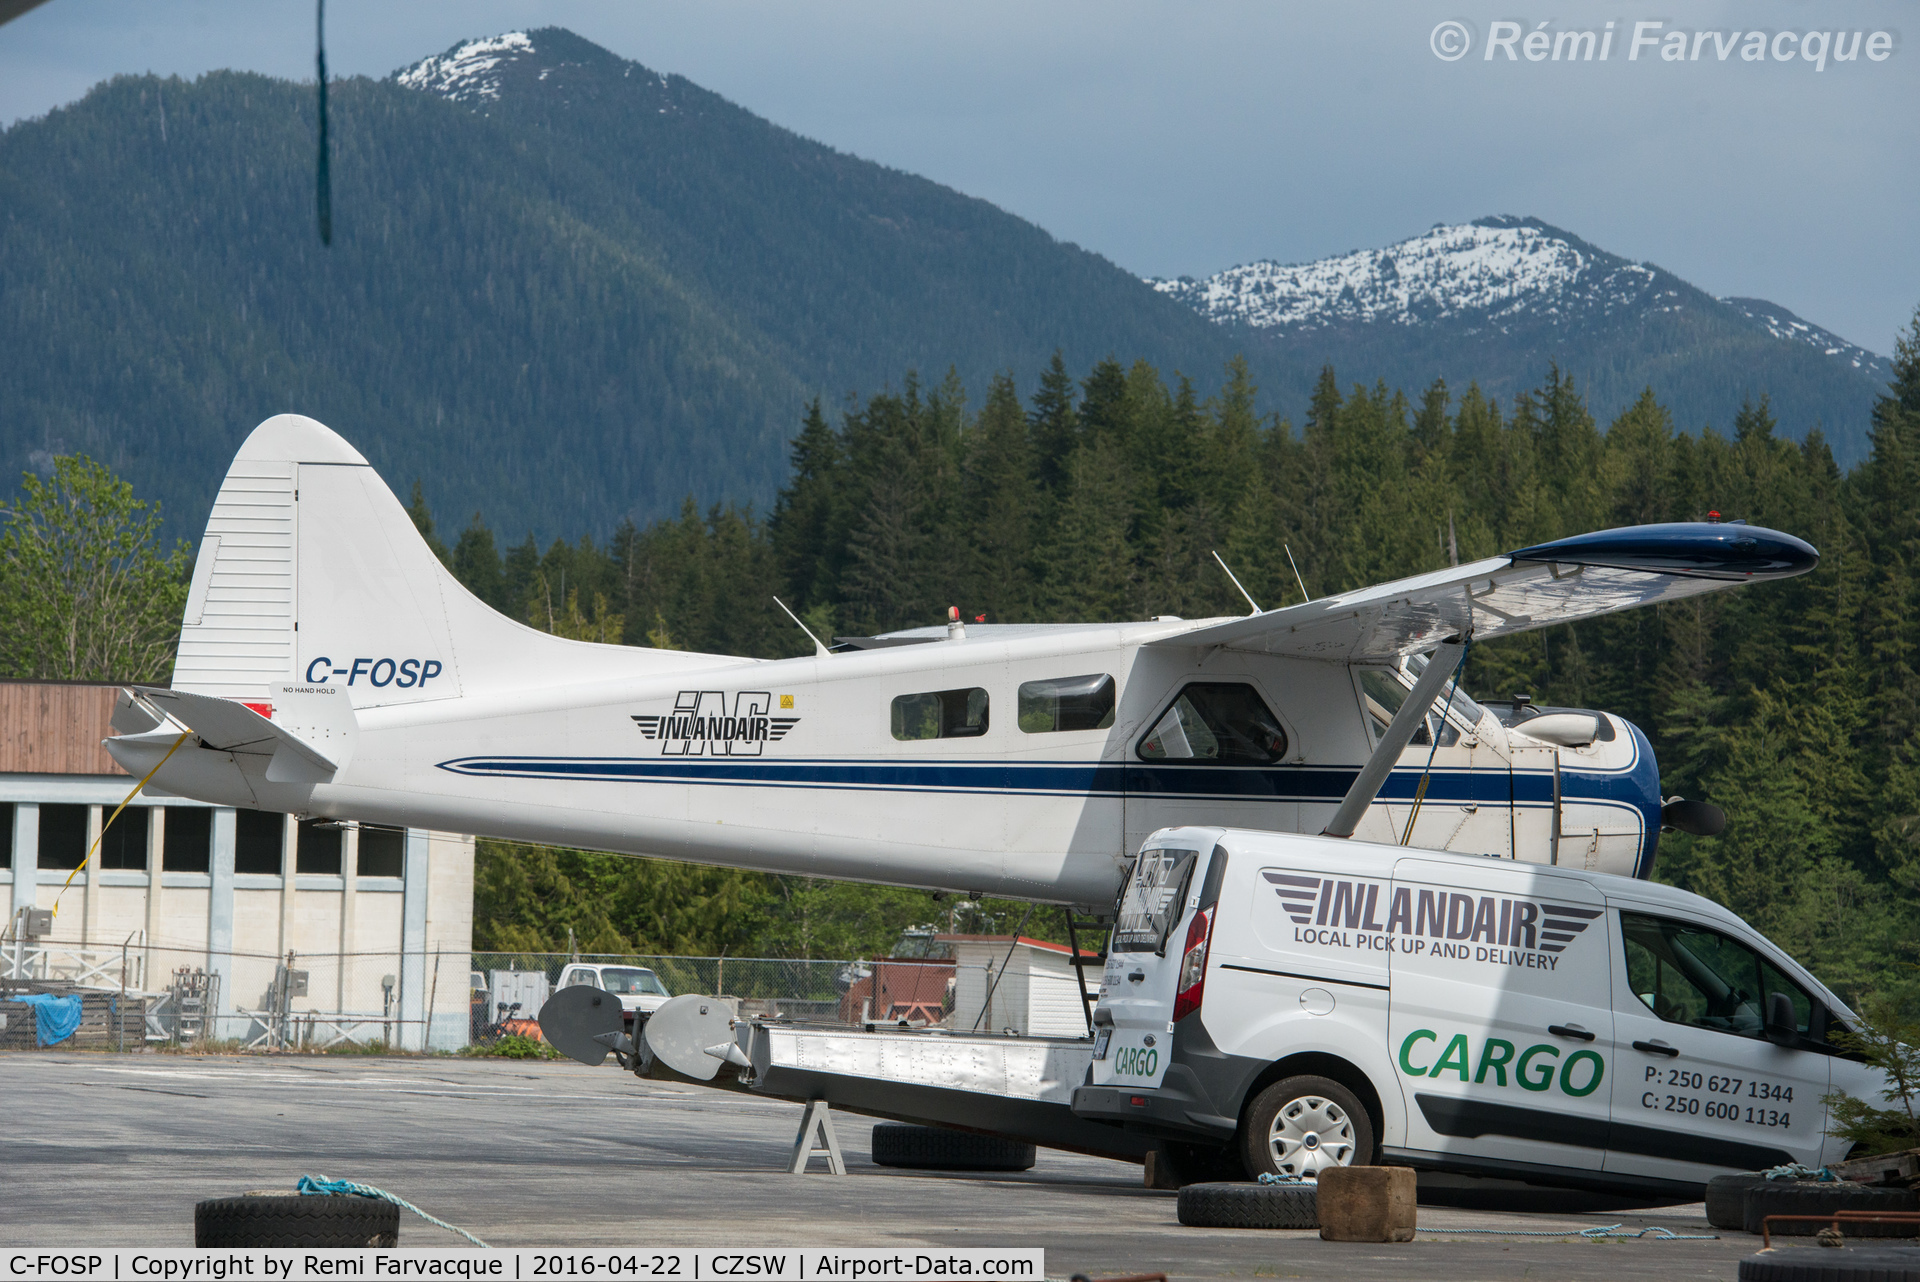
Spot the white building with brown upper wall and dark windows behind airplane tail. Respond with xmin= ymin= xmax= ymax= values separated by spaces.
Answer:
xmin=0 ymin=681 xmax=474 ymax=1050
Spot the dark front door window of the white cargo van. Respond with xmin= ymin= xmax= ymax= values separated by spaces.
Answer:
xmin=1620 ymin=912 xmax=1814 ymax=1036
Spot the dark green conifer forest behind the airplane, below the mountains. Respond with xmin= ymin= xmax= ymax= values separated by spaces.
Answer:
xmin=385 ymin=319 xmax=1920 ymax=1000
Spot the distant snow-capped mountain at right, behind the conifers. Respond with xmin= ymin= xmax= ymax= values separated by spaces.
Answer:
xmin=1146 ymin=215 xmax=1889 ymax=463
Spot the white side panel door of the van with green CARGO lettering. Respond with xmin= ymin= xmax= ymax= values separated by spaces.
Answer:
xmin=1386 ymin=860 xmax=1619 ymax=1171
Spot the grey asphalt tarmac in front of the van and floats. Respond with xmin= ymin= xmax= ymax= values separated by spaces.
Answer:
xmin=0 ymin=1052 xmax=1816 ymax=1282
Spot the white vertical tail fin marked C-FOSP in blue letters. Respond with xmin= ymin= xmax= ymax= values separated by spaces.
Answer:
xmin=173 ymin=415 xmax=741 ymax=716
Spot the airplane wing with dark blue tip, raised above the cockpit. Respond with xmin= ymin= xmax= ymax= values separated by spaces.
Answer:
xmin=1148 ymin=522 xmax=1820 ymax=662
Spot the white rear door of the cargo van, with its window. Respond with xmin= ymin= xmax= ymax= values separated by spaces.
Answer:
xmin=1092 ymin=837 xmax=1212 ymax=1088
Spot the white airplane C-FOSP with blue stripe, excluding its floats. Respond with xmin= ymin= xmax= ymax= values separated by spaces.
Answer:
xmin=106 ymin=415 xmax=1818 ymax=910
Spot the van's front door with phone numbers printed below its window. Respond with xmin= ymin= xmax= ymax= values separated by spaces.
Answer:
xmin=1607 ymin=906 xmax=1832 ymax=1180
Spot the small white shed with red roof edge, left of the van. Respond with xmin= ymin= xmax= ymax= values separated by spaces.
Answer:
xmin=939 ymin=935 xmax=1100 ymax=1036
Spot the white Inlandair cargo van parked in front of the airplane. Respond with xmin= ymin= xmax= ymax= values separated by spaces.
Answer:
xmin=1073 ymin=827 xmax=1880 ymax=1198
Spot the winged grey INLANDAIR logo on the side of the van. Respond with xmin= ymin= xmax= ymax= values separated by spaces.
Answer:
xmin=1260 ymin=867 xmax=1605 ymax=969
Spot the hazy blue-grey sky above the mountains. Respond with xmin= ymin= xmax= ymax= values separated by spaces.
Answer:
xmin=0 ymin=0 xmax=1920 ymax=353
